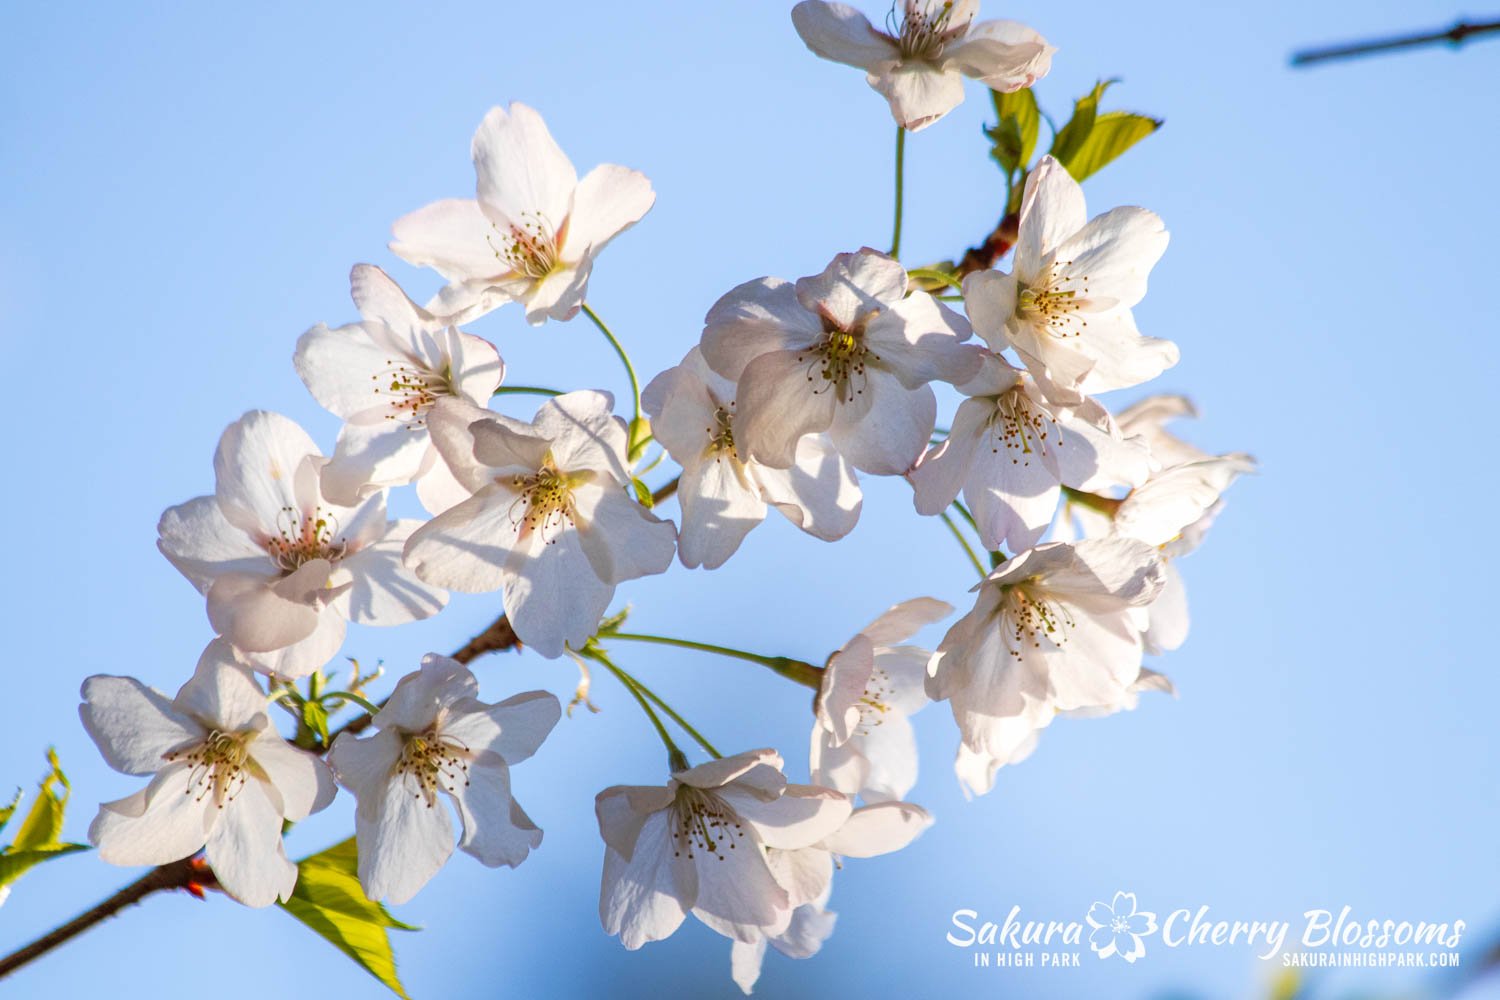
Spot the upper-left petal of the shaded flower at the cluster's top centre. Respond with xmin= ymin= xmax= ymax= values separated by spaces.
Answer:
xmin=701 ymin=277 xmax=824 ymax=382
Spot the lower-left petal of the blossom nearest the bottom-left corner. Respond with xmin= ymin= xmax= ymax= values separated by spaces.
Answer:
xmin=89 ymin=765 xmax=218 ymax=865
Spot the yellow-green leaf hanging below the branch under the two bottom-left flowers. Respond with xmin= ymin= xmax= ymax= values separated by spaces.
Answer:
xmin=281 ymin=838 xmax=417 ymax=1000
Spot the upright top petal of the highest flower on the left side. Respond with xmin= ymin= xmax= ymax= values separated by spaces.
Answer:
xmin=473 ymin=100 xmax=578 ymax=229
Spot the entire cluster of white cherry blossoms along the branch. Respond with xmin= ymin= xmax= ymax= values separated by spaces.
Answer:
xmin=73 ymin=0 xmax=1253 ymax=991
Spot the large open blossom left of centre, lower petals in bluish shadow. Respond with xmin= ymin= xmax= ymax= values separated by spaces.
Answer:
xmin=405 ymin=391 xmax=677 ymax=657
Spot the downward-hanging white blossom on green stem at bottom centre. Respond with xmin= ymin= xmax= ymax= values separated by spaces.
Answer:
xmin=594 ymin=750 xmax=851 ymax=951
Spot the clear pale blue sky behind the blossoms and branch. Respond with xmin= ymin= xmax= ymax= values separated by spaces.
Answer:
xmin=0 ymin=0 xmax=1500 ymax=1000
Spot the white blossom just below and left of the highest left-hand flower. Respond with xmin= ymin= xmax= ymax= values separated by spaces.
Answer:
xmin=293 ymin=264 xmax=506 ymax=514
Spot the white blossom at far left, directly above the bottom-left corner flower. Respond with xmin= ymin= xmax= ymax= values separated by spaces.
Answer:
xmin=156 ymin=411 xmax=447 ymax=678
